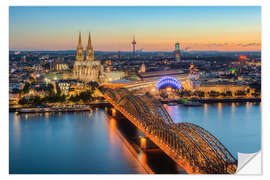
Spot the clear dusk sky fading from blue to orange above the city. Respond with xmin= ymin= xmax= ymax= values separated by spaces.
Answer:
xmin=9 ymin=6 xmax=261 ymax=51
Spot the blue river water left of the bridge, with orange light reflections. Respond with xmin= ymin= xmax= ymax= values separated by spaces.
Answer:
xmin=9 ymin=112 xmax=148 ymax=174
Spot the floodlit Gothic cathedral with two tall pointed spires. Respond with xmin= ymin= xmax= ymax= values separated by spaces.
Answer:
xmin=73 ymin=33 xmax=105 ymax=83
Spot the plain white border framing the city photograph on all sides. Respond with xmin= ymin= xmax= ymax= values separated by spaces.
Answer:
xmin=0 ymin=0 xmax=270 ymax=180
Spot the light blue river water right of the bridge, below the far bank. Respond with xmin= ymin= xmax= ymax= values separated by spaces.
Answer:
xmin=166 ymin=103 xmax=261 ymax=157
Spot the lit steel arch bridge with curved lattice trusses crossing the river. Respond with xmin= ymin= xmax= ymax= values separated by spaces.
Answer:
xmin=102 ymin=88 xmax=237 ymax=174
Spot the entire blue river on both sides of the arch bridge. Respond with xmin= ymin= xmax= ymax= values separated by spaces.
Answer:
xmin=9 ymin=103 xmax=261 ymax=174
